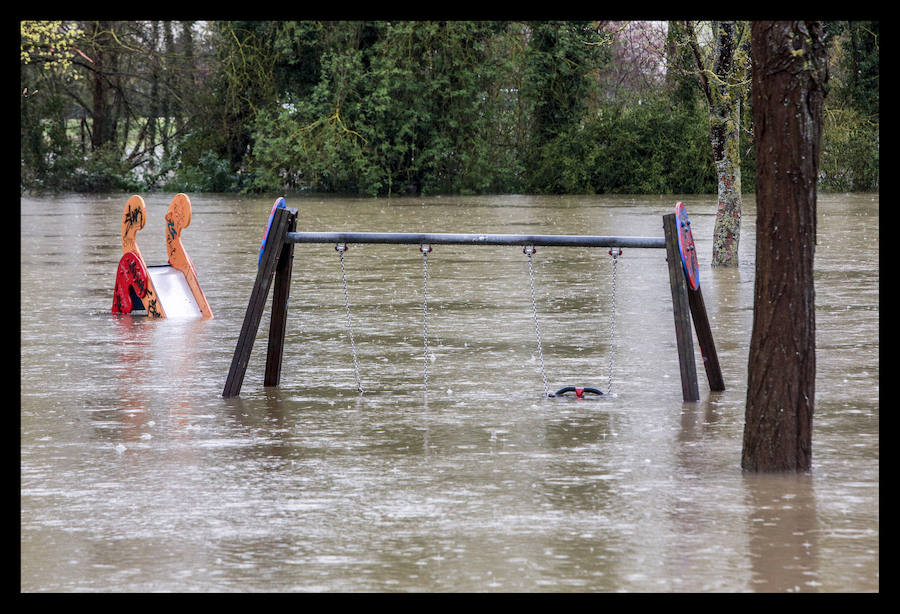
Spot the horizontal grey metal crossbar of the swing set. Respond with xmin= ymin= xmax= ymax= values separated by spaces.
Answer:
xmin=284 ymin=232 xmax=666 ymax=248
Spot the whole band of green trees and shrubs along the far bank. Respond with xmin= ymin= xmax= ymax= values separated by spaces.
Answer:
xmin=20 ymin=21 xmax=879 ymax=195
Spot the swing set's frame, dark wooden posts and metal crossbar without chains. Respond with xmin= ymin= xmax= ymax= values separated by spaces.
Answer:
xmin=222 ymin=208 xmax=725 ymax=401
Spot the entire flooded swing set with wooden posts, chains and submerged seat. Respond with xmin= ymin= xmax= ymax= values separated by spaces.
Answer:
xmin=222 ymin=198 xmax=725 ymax=401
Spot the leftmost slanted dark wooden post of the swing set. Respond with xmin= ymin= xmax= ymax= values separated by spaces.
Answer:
xmin=222 ymin=208 xmax=297 ymax=398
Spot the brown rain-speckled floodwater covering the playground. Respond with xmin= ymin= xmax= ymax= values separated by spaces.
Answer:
xmin=20 ymin=194 xmax=879 ymax=592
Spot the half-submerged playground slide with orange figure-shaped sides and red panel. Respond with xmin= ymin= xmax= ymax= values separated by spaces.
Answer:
xmin=112 ymin=194 xmax=213 ymax=319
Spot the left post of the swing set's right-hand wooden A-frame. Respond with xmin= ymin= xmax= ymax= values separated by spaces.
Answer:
xmin=663 ymin=213 xmax=700 ymax=401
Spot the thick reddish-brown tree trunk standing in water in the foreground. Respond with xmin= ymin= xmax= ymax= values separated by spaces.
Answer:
xmin=741 ymin=21 xmax=827 ymax=471
